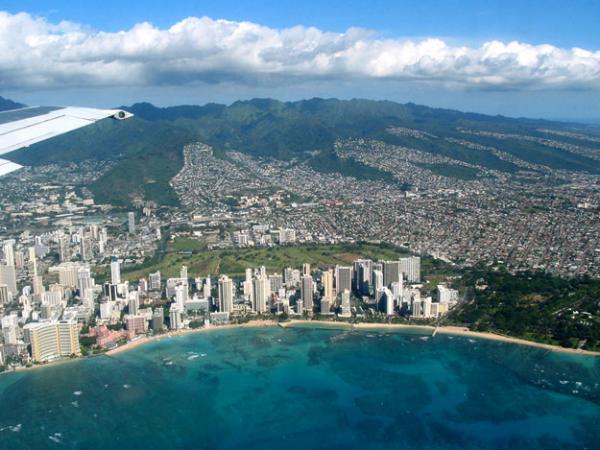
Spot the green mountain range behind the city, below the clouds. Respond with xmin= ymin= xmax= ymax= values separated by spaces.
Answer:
xmin=0 ymin=97 xmax=600 ymax=205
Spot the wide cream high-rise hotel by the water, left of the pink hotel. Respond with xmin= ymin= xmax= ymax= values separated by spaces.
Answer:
xmin=23 ymin=320 xmax=81 ymax=362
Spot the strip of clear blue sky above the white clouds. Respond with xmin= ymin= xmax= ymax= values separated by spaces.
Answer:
xmin=1 ymin=0 xmax=600 ymax=49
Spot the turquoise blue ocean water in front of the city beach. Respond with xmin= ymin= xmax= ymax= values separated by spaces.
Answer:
xmin=0 ymin=328 xmax=600 ymax=450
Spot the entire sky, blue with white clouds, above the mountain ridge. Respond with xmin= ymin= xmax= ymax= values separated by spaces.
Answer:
xmin=0 ymin=0 xmax=600 ymax=119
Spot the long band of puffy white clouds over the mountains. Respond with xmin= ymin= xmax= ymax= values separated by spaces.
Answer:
xmin=0 ymin=12 xmax=600 ymax=90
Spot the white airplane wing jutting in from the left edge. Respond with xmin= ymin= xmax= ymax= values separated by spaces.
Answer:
xmin=0 ymin=106 xmax=133 ymax=177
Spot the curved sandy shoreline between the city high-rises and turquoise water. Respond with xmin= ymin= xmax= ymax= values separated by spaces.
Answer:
xmin=0 ymin=320 xmax=600 ymax=376
